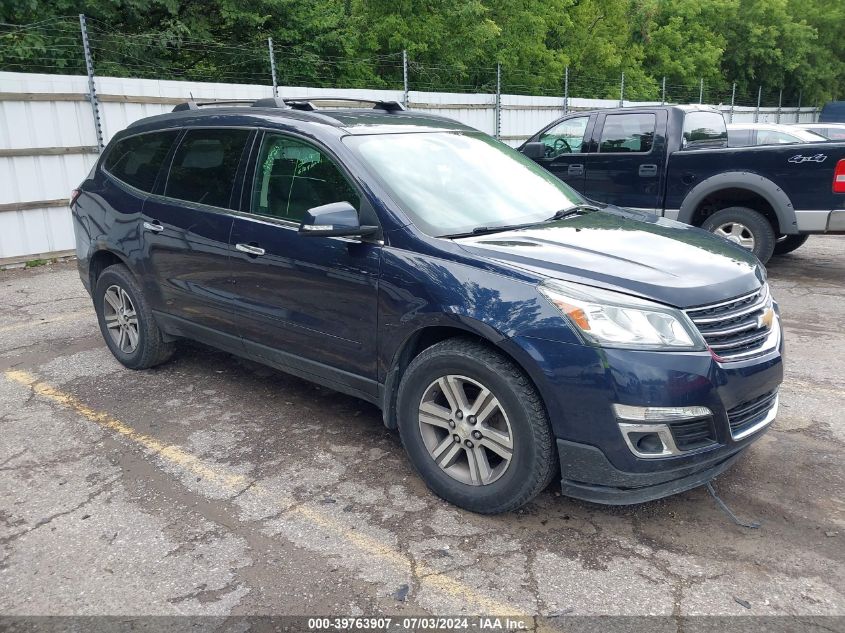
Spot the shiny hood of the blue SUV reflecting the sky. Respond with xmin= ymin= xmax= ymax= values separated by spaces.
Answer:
xmin=455 ymin=207 xmax=766 ymax=308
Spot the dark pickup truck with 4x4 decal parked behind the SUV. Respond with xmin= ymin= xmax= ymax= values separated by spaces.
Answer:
xmin=520 ymin=106 xmax=845 ymax=262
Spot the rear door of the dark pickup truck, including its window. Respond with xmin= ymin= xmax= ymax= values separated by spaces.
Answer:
xmin=576 ymin=109 xmax=666 ymax=212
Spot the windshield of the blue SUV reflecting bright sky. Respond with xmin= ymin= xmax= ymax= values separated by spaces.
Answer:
xmin=344 ymin=132 xmax=584 ymax=237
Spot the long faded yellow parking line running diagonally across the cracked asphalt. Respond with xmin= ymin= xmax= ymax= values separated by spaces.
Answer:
xmin=5 ymin=370 xmax=530 ymax=621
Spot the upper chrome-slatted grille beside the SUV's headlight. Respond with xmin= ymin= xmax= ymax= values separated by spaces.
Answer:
xmin=686 ymin=284 xmax=772 ymax=360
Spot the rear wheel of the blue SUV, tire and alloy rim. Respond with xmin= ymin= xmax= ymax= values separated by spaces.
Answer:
xmin=94 ymin=264 xmax=174 ymax=369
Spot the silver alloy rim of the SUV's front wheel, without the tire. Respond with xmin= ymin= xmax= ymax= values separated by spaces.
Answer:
xmin=419 ymin=374 xmax=513 ymax=486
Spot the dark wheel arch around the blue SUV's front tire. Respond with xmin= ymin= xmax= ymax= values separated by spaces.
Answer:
xmin=382 ymin=318 xmax=546 ymax=430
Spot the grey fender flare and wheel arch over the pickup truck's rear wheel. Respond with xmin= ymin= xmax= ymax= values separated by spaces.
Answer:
xmin=678 ymin=171 xmax=798 ymax=234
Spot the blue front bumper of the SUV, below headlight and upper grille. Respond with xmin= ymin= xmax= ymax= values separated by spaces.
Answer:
xmin=504 ymin=323 xmax=783 ymax=505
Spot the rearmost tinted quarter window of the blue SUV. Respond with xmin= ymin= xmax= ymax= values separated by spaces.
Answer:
xmin=103 ymin=130 xmax=179 ymax=193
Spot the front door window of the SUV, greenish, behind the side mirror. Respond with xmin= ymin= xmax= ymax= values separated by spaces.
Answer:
xmin=252 ymin=134 xmax=360 ymax=222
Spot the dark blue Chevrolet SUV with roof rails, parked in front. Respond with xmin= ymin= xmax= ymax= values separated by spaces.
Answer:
xmin=72 ymin=99 xmax=783 ymax=513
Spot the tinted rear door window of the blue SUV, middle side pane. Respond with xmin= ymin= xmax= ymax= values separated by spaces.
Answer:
xmin=164 ymin=129 xmax=250 ymax=208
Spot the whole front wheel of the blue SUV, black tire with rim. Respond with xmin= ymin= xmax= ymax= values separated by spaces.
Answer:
xmin=397 ymin=339 xmax=557 ymax=514
